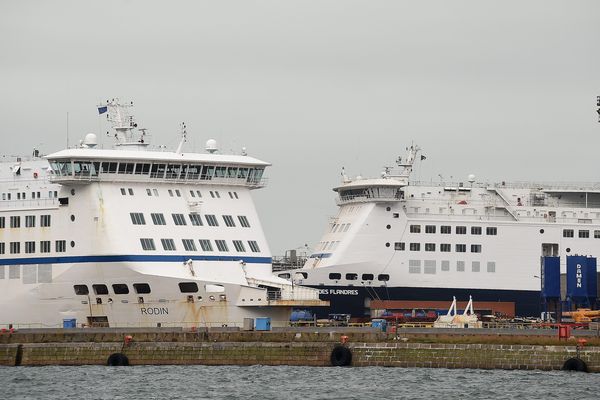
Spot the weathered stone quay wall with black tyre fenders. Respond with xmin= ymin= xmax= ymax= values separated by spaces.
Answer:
xmin=0 ymin=327 xmax=600 ymax=372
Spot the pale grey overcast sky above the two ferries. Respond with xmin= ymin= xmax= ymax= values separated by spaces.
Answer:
xmin=0 ymin=0 xmax=600 ymax=254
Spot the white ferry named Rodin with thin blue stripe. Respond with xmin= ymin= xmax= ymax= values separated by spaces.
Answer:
xmin=0 ymin=100 xmax=325 ymax=328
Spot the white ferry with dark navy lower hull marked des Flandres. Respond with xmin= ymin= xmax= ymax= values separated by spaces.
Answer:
xmin=279 ymin=146 xmax=600 ymax=317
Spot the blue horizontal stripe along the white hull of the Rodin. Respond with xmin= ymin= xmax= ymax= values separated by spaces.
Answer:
xmin=0 ymin=255 xmax=272 ymax=265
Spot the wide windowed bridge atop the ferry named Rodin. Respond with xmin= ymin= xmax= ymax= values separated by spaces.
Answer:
xmin=46 ymin=148 xmax=271 ymax=189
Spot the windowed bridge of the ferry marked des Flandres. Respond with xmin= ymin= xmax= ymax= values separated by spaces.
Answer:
xmin=333 ymin=178 xmax=406 ymax=205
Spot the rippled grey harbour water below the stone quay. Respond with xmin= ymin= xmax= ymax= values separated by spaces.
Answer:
xmin=0 ymin=366 xmax=600 ymax=400
